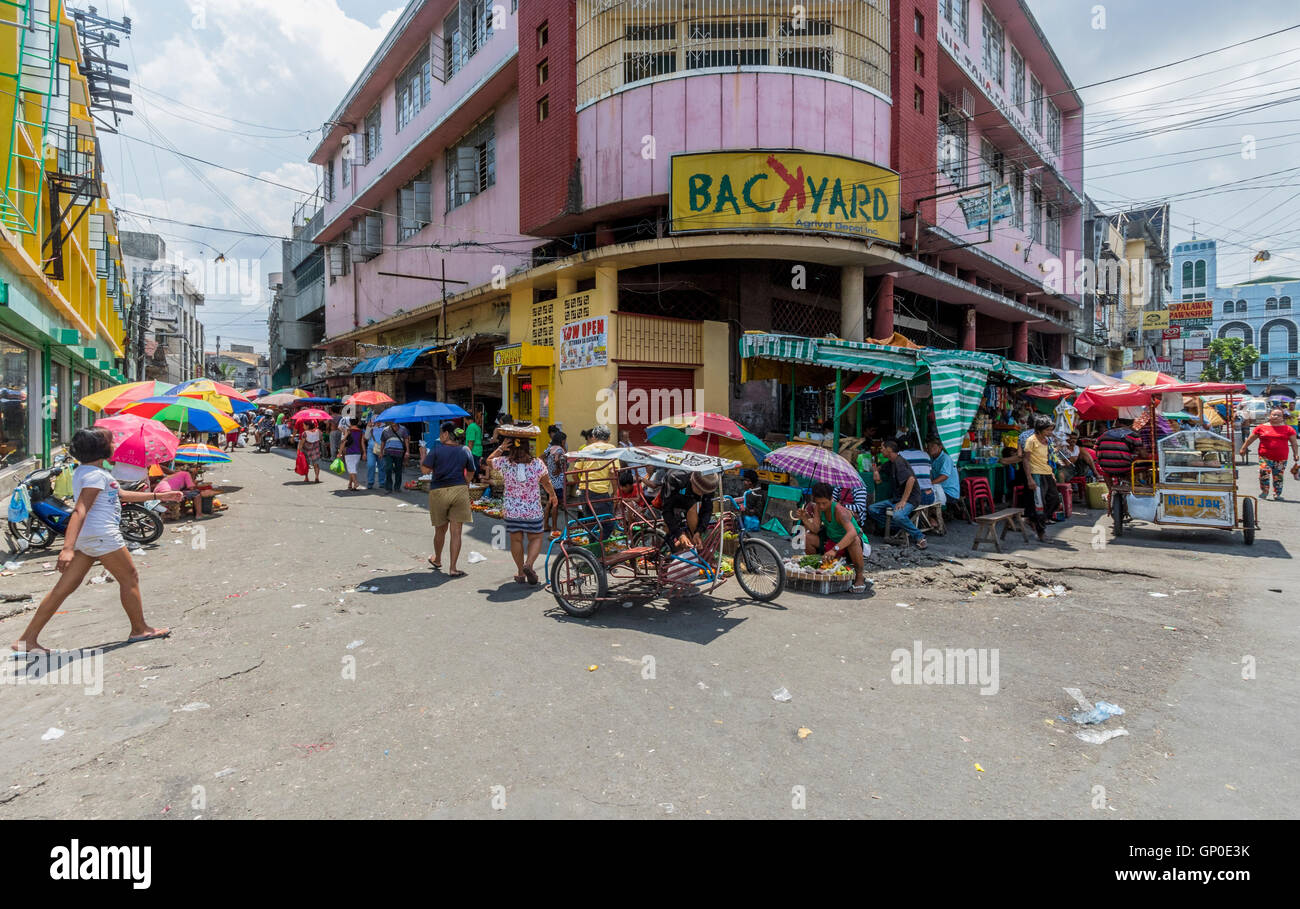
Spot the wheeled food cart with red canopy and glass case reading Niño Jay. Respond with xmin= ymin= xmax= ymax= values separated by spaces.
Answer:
xmin=1075 ymin=382 xmax=1258 ymax=546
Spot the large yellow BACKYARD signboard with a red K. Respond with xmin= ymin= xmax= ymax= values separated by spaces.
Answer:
xmin=668 ymin=151 xmax=898 ymax=243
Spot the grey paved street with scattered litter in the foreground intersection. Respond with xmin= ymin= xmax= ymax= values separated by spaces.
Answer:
xmin=0 ymin=451 xmax=1300 ymax=818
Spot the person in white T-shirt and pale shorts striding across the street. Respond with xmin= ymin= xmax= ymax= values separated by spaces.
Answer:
xmin=10 ymin=429 xmax=181 ymax=653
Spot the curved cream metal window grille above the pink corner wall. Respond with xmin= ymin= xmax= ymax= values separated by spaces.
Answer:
xmin=577 ymin=0 xmax=889 ymax=107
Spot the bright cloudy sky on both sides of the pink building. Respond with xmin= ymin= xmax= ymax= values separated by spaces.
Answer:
xmin=91 ymin=0 xmax=1300 ymax=350
